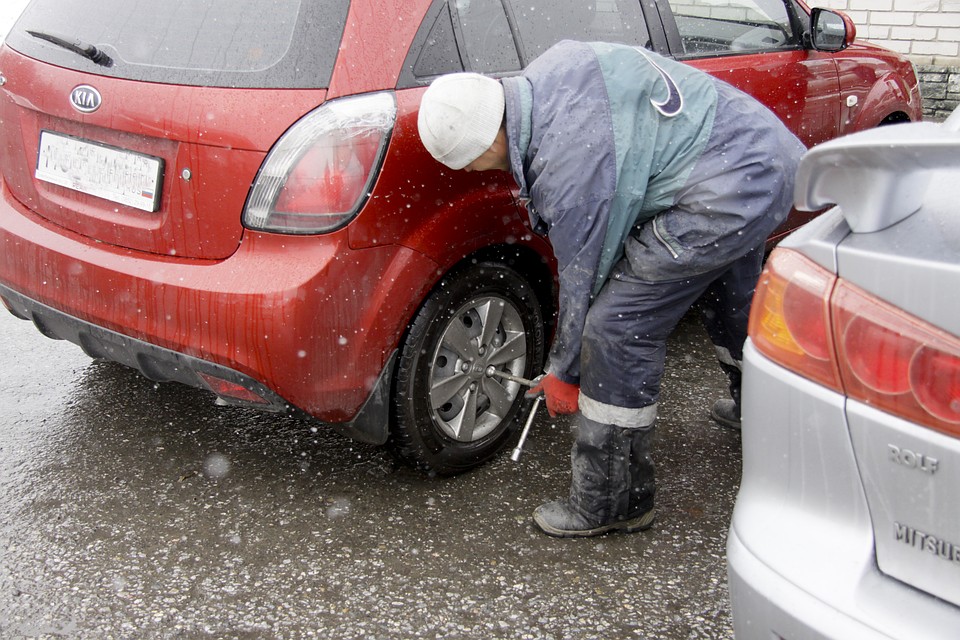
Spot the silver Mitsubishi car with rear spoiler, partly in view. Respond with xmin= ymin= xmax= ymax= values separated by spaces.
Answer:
xmin=727 ymin=110 xmax=960 ymax=640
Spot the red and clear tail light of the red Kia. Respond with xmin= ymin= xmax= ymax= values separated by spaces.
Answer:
xmin=243 ymin=93 xmax=397 ymax=234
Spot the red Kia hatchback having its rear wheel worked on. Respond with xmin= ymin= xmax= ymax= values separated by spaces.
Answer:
xmin=0 ymin=0 xmax=921 ymax=473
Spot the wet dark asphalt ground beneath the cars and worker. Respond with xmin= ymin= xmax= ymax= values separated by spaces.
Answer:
xmin=0 ymin=309 xmax=740 ymax=640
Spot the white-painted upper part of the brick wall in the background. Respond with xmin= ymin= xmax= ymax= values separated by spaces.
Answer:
xmin=808 ymin=0 xmax=960 ymax=67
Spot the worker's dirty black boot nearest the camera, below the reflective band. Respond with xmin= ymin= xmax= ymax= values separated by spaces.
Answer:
xmin=533 ymin=416 xmax=655 ymax=538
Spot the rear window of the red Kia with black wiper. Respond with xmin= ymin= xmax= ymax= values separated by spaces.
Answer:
xmin=7 ymin=0 xmax=350 ymax=88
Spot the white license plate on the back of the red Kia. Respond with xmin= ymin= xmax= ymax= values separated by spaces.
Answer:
xmin=36 ymin=131 xmax=163 ymax=211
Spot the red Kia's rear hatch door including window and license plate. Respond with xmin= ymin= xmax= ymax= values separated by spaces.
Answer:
xmin=0 ymin=0 xmax=348 ymax=259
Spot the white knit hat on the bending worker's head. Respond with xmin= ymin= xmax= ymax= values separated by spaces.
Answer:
xmin=417 ymin=73 xmax=503 ymax=169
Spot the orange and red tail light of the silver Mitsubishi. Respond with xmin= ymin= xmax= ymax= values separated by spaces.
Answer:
xmin=750 ymin=249 xmax=960 ymax=436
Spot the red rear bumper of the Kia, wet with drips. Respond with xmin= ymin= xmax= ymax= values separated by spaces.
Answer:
xmin=0 ymin=180 xmax=437 ymax=424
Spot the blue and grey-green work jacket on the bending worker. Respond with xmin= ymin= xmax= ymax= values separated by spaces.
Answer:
xmin=502 ymin=41 xmax=803 ymax=382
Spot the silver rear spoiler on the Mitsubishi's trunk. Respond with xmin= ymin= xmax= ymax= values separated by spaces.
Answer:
xmin=794 ymin=108 xmax=960 ymax=233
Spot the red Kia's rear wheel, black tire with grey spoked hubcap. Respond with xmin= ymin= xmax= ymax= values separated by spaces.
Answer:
xmin=389 ymin=263 xmax=544 ymax=475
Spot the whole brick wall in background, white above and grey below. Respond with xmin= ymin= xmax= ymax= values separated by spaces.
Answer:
xmin=808 ymin=0 xmax=960 ymax=119
